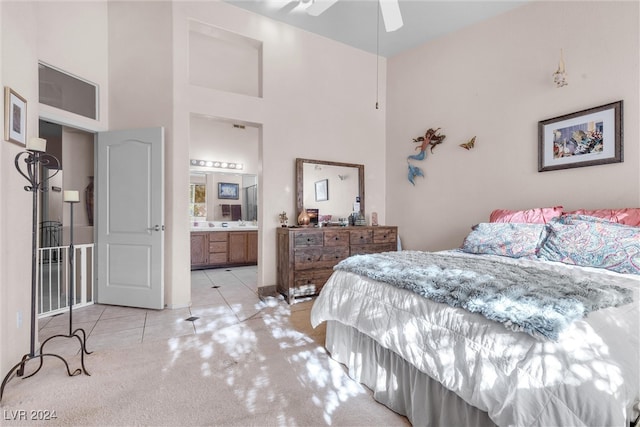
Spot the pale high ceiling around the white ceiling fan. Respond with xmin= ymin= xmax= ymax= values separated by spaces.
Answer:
xmin=224 ymin=0 xmax=530 ymax=58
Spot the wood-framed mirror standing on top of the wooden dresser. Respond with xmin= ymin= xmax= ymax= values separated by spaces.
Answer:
xmin=292 ymin=159 xmax=365 ymax=223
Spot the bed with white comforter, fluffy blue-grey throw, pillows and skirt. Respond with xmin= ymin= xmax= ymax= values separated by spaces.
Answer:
xmin=311 ymin=210 xmax=640 ymax=426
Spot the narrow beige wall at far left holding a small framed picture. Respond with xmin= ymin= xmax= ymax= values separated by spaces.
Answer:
xmin=0 ymin=3 xmax=38 ymax=386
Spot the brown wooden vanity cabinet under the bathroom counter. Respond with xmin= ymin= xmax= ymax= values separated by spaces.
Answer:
xmin=191 ymin=230 xmax=258 ymax=270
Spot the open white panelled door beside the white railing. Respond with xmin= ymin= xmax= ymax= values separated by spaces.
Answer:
xmin=95 ymin=128 xmax=164 ymax=309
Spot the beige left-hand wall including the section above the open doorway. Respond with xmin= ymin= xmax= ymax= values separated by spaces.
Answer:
xmin=0 ymin=1 xmax=108 ymax=375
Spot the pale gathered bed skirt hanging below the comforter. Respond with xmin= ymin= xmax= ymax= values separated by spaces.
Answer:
xmin=326 ymin=321 xmax=495 ymax=427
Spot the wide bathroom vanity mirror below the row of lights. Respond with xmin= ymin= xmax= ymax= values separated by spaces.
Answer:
xmin=189 ymin=169 xmax=258 ymax=222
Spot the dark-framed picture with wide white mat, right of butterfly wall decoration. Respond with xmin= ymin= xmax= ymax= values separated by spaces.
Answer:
xmin=538 ymin=101 xmax=623 ymax=172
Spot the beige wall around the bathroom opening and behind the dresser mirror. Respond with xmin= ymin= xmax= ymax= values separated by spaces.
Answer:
xmin=169 ymin=2 xmax=385 ymax=300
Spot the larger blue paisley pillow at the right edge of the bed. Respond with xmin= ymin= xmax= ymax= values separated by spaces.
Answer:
xmin=538 ymin=215 xmax=640 ymax=274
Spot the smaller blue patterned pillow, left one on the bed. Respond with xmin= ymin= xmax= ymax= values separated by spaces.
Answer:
xmin=462 ymin=222 xmax=545 ymax=258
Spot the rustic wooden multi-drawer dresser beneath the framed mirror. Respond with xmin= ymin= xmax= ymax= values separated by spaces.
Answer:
xmin=277 ymin=226 xmax=398 ymax=304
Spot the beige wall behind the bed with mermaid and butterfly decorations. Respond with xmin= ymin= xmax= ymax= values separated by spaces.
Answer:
xmin=386 ymin=1 xmax=640 ymax=250
